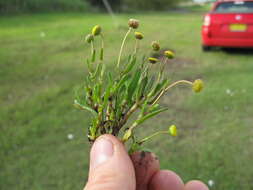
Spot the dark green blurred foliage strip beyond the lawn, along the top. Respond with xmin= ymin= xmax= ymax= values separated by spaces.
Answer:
xmin=0 ymin=0 xmax=187 ymax=14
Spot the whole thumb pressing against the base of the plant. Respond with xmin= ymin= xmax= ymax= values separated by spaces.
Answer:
xmin=84 ymin=135 xmax=136 ymax=190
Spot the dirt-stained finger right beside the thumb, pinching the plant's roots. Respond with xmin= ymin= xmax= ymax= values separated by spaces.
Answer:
xmin=131 ymin=151 xmax=159 ymax=190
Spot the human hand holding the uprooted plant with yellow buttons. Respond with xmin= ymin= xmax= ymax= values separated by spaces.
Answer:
xmin=84 ymin=135 xmax=208 ymax=190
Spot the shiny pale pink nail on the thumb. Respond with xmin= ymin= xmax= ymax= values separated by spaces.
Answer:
xmin=90 ymin=138 xmax=114 ymax=169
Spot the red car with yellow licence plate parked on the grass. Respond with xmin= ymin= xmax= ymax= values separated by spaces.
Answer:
xmin=202 ymin=0 xmax=253 ymax=51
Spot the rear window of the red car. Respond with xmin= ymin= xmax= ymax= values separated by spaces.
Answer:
xmin=214 ymin=1 xmax=253 ymax=13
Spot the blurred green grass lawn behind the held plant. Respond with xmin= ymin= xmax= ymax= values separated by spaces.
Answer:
xmin=0 ymin=13 xmax=253 ymax=190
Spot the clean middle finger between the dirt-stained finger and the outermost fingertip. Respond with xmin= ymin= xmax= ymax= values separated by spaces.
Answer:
xmin=149 ymin=170 xmax=184 ymax=190
